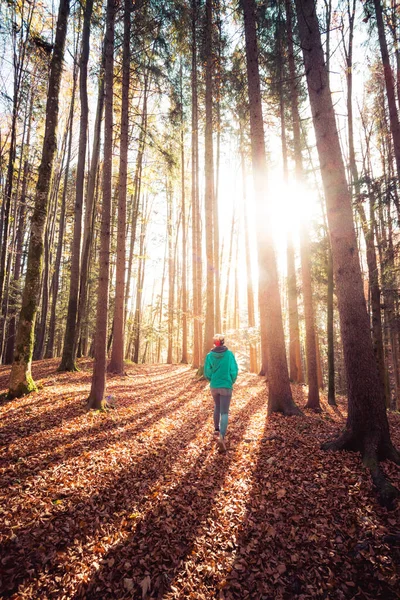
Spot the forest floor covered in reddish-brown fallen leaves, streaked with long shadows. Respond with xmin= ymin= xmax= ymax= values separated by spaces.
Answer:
xmin=0 ymin=360 xmax=400 ymax=600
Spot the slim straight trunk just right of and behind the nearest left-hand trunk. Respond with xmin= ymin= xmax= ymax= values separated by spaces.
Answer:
xmin=108 ymin=0 xmax=131 ymax=375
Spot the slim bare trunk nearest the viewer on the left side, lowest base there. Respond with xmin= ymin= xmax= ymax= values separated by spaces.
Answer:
xmin=88 ymin=0 xmax=117 ymax=409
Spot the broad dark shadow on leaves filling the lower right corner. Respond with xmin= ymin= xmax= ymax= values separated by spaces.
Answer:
xmin=223 ymin=416 xmax=399 ymax=600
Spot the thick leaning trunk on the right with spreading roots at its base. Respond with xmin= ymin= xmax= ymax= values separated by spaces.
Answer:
xmin=296 ymin=0 xmax=400 ymax=506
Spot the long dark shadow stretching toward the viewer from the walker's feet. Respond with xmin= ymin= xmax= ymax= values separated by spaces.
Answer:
xmin=70 ymin=393 xmax=266 ymax=599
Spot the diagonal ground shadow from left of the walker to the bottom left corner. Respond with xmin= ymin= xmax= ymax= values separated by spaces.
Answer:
xmin=0 ymin=380 xmax=210 ymax=597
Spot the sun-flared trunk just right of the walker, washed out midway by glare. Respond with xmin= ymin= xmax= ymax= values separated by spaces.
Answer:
xmin=243 ymin=0 xmax=301 ymax=415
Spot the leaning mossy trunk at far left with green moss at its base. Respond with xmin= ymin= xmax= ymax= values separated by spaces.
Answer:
xmin=9 ymin=0 xmax=70 ymax=397
